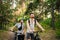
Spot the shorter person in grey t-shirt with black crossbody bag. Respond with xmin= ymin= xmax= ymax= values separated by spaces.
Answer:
xmin=11 ymin=19 xmax=24 ymax=40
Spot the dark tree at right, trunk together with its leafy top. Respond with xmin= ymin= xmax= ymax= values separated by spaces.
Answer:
xmin=48 ymin=0 xmax=56 ymax=29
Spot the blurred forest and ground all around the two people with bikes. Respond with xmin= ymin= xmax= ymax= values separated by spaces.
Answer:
xmin=0 ymin=0 xmax=60 ymax=40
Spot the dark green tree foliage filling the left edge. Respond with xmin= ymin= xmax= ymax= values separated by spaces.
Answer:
xmin=0 ymin=0 xmax=13 ymax=29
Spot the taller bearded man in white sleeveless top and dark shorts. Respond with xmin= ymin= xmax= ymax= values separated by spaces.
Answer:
xmin=27 ymin=13 xmax=44 ymax=40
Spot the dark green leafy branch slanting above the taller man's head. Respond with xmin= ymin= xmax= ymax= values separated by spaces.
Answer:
xmin=25 ymin=0 xmax=40 ymax=14
